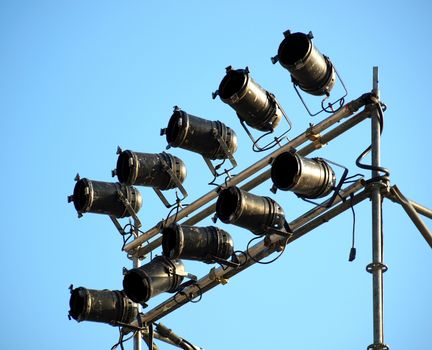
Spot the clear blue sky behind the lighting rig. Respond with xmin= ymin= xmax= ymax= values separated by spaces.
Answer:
xmin=0 ymin=0 xmax=432 ymax=350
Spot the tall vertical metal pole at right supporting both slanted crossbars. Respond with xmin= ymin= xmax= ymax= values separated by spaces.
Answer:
xmin=368 ymin=67 xmax=387 ymax=349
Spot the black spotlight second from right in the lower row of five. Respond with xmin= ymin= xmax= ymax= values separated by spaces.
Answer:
xmin=216 ymin=186 xmax=289 ymax=235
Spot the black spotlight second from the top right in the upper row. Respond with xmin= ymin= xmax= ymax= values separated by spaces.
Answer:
xmin=218 ymin=67 xmax=283 ymax=131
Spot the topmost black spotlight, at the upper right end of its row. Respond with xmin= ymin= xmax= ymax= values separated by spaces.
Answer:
xmin=277 ymin=31 xmax=336 ymax=96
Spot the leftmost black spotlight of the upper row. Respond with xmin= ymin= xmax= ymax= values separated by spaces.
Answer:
xmin=68 ymin=175 xmax=142 ymax=218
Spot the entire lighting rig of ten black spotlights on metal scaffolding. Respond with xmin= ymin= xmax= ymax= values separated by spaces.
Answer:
xmin=68 ymin=31 xmax=432 ymax=350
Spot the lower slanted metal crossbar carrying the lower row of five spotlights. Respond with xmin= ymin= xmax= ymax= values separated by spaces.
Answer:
xmin=134 ymin=183 xmax=369 ymax=323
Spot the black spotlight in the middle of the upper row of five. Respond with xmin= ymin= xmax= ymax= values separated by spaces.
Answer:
xmin=165 ymin=108 xmax=237 ymax=160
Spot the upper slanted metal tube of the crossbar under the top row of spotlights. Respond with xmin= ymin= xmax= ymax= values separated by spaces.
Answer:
xmin=124 ymin=97 xmax=366 ymax=252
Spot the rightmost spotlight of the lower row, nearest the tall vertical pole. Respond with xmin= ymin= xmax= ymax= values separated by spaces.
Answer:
xmin=271 ymin=152 xmax=336 ymax=199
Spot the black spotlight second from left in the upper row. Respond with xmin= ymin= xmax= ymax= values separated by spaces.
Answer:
xmin=115 ymin=150 xmax=187 ymax=190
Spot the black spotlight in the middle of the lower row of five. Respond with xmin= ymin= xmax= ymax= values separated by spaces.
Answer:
xmin=162 ymin=224 xmax=234 ymax=264
